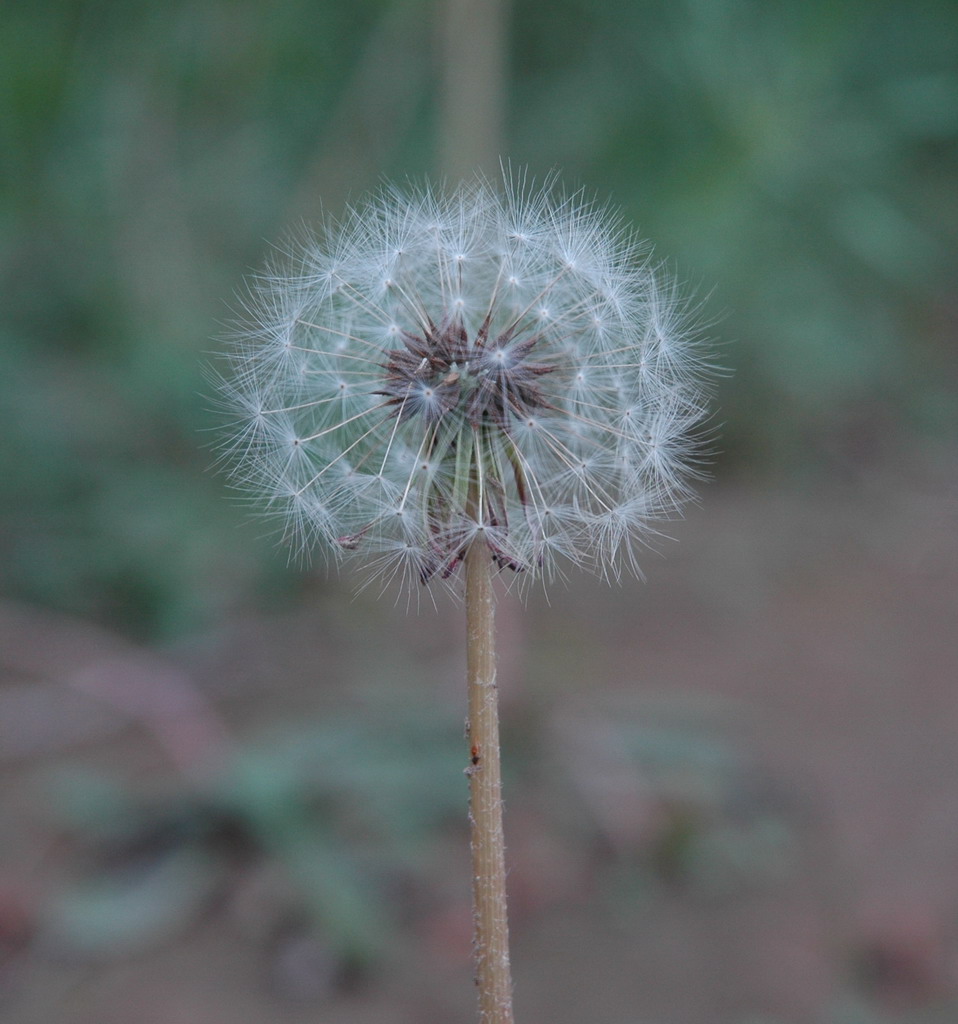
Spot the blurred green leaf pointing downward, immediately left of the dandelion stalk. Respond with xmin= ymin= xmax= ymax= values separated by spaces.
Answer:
xmin=211 ymin=697 xmax=466 ymax=961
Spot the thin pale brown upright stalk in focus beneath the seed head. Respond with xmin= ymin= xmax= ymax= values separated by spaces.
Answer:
xmin=466 ymin=540 xmax=513 ymax=1024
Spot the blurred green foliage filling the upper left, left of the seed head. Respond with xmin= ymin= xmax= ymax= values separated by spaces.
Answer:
xmin=0 ymin=0 xmax=397 ymax=635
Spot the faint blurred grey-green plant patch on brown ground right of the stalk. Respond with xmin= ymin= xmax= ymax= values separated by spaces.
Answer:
xmin=550 ymin=697 xmax=800 ymax=906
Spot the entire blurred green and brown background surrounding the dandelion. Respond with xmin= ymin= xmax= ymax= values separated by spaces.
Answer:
xmin=0 ymin=0 xmax=958 ymax=1024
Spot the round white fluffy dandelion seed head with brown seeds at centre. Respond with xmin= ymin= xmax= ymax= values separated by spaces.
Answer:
xmin=214 ymin=175 xmax=709 ymax=585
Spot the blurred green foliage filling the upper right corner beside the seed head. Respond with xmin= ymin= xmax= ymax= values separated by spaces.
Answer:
xmin=505 ymin=0 xmax=958 ymax=466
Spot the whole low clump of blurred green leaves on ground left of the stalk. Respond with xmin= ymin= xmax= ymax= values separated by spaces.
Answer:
xmin=29 ymin=698 xmax=466 ymax=966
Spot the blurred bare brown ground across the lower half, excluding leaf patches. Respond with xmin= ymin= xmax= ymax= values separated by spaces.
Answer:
xmin=0 ymin=451 xmax=958 ymax=1024
